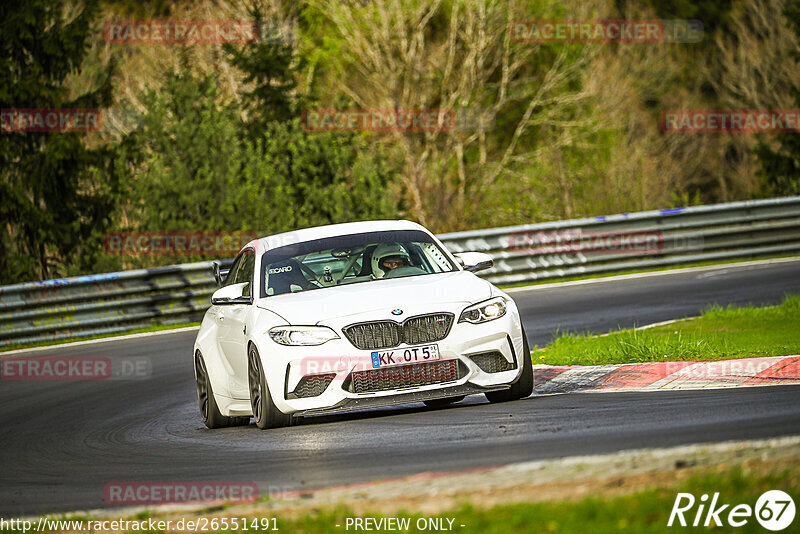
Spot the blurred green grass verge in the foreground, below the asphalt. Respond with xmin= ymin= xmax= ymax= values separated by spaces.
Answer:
xmin=23 ymin=456 xmax=800 ymax=534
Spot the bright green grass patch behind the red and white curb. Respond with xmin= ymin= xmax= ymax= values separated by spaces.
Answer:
xmin=533 ymin=295 xmax=800 ymax=365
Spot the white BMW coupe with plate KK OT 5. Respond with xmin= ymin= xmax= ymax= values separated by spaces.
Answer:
xmin=194 ymin=221 xmax=533 ymax=429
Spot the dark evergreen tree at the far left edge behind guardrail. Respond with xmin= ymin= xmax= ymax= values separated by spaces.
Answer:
xmin=0 ymin=0 xmax=115 ymax=283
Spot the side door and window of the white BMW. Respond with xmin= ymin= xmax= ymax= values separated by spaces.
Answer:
xmin=216 ymin=249 xmax=256 ymax=399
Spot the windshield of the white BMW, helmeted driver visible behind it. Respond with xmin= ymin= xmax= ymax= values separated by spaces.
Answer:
xmin=261 ymin=230 xmax=457 ymax=297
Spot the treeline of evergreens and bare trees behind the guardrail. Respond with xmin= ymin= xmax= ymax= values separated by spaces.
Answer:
xmin=0 ymin=0 xmax=800 ymax=284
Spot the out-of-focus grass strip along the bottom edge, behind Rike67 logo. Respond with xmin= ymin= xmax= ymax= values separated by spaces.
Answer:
xmin=17 ymin=460 xmax=800 ymax=534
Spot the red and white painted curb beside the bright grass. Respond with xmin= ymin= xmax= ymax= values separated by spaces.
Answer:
xmin=533 ymin=356 xmax=800 ymax=394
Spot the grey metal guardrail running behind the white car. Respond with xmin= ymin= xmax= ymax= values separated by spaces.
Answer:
xmin=0 ymin=197 xmax=800 ymax=347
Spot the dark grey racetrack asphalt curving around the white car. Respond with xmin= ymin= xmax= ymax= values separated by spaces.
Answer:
xmin=0 ymin=261 xmax=800 ymax=517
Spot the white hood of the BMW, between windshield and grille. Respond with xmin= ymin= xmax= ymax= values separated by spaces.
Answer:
xmin=256 ymin=271 xmax=493 ymax=325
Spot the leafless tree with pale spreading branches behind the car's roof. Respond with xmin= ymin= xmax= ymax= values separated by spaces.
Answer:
xmin=307 ymin=0 xmax=592 ymax=231
